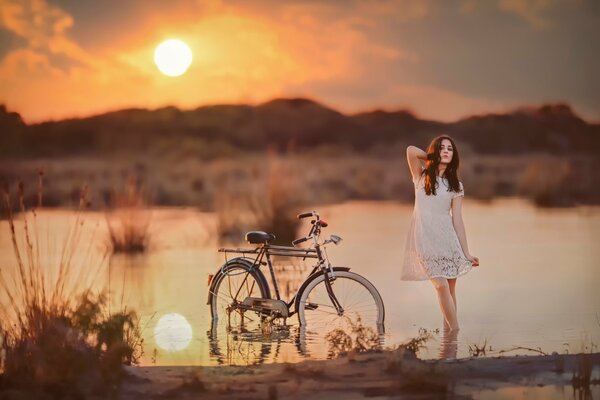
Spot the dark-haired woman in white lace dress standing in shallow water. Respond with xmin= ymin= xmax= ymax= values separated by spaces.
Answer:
xmin=402 ymin=135 xmax=479 ymax=332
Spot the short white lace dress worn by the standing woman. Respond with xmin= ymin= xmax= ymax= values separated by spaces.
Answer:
xmin=401 ymin=175 xmax=473 ymax=281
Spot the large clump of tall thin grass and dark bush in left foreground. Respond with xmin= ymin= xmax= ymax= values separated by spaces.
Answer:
xmin=0 ymin=180 xmax=142 ymax=398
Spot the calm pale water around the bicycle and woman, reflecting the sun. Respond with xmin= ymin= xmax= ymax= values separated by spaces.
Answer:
xmin=0 ymin=199 xmax=600 ymax=365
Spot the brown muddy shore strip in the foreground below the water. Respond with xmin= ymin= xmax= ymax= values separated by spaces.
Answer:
xmin=121 ymin=349 xmax=600 ymax=399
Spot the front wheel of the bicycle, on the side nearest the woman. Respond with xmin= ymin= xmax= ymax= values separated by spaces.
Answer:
xmin=298 ymin=271 xmax=385 ymax=332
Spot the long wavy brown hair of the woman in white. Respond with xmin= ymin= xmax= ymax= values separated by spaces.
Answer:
xmin=423 ymin=135 xmax=460 ymax=195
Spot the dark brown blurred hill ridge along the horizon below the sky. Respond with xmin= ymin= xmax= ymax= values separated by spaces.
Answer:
xmin=0 ymin=98 xmax=600 ymax=158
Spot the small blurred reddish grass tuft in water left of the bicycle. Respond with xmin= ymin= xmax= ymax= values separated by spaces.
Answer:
xmin=105 ymin=179 xmax=152 ymax=253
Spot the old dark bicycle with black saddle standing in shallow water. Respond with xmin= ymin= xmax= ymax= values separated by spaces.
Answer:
xmin=207 ymin=211 xmax=385 ymax=332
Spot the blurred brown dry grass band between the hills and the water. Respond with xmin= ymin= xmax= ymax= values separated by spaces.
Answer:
xmin=0 ymin=149 xmax=600 ymax=212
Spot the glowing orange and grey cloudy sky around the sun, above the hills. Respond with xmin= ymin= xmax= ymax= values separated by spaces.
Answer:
xmin=0 ymin=0 xmax=600 ymax=122
